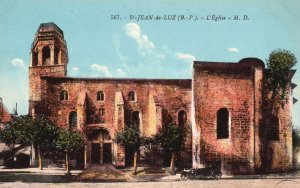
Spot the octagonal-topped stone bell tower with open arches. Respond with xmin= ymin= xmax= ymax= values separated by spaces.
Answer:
xmin=29 ymin=22 xmax=68 ymax=115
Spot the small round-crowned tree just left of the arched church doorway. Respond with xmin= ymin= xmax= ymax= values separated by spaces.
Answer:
xmin=56 ymin=129 xmax=84 ymax=175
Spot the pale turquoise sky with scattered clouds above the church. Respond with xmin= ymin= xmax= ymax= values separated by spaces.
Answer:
xmin=0 ymin=0 xmax=300 ymax=127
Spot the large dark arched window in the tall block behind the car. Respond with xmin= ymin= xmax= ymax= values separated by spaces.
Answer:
xmin=217 ymin=108 xmax=229 ymax=139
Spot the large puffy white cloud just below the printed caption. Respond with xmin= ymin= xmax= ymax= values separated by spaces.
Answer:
xmin=124 ymin=23 xmax=155 ymax=56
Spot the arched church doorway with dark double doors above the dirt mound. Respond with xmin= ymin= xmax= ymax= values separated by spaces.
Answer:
xmin=88 ymin=129 xmax=112 ymax=164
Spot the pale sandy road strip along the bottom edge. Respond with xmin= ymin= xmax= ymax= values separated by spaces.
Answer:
xmin=0 ymin=179 xmax=300 ymax=188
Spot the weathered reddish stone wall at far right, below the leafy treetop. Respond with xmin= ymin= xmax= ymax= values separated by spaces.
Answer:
xmin=261 ymin=70 xmax=293 ymax=172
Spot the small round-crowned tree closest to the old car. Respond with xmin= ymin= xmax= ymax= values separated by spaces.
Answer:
xmin=154 ymin=124 xmax=185 ymax=174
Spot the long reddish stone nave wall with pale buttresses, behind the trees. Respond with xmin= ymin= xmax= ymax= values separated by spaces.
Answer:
xmin=38 ymin=77 xmax=191 ymax=166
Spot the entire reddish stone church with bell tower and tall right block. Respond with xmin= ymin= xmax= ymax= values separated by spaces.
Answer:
xmin=29 ymin=23 xmax=292 ymax=174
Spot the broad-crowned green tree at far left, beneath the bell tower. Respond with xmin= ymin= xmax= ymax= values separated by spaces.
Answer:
xmin=0 ymin=115 xmax=58 ymax=170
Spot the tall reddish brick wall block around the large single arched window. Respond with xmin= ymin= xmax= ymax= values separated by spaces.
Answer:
xmin=193 ymin=60 xmax=261 ymax=174
